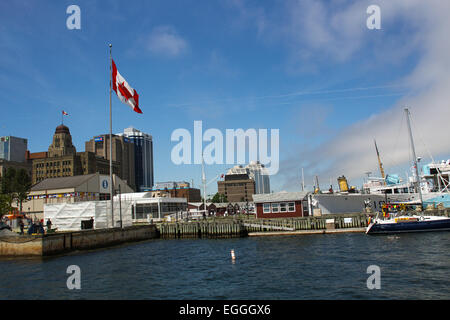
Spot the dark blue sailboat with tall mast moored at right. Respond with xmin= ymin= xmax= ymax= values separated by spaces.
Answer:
xmin=366 ymin=108 xmax=450 ymax=234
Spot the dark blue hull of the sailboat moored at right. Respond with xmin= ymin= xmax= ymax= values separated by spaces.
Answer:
xmin=366 ymin=219 xmax=450 ymax=234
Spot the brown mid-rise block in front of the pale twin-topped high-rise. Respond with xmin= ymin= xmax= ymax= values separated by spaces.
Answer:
xmin=217 ymin=173 xmax=255 ymax=202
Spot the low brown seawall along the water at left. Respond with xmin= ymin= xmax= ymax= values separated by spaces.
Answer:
xmin=0 ymin=225 xmax=158 ymax=257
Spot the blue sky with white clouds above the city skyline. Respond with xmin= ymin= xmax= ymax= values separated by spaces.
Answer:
xmin=0 ymin=0 xmax=450 ymax=193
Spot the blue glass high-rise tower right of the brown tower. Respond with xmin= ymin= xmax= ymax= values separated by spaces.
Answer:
xmin=117 ymin=127 xmax=154 ymax=191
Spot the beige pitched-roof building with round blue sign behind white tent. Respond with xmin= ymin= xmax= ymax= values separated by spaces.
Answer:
xmin=23 ymin=172 xmax=133 ymax=217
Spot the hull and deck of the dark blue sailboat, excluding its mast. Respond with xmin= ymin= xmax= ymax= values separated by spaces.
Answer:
xmin=366 ymin=215 xmax=450 ymax=234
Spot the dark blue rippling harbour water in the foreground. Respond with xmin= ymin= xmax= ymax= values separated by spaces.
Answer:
xmin=0 ymin=232 xmax=450 ymax=300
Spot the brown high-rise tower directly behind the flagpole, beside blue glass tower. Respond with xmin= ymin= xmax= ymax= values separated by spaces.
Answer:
xmin=85 ymin=134 xmax=136 ymax=190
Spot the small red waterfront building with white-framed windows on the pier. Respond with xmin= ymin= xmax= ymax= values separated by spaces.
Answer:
xmin=253 ymin=191 xmax=309 ymax=218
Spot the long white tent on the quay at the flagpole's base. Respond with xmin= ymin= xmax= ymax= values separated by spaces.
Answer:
xmin=44 ymin=200 xmax=132 ymax=231
